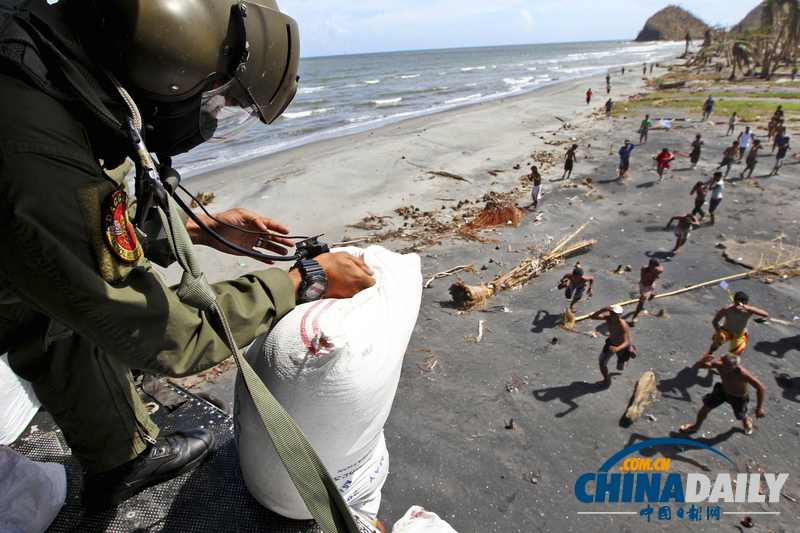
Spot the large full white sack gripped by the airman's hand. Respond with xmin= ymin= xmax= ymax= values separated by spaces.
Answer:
xmin=234 ymin=246 xmax=422 ymax=522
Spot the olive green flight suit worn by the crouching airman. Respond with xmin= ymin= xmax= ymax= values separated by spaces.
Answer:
xmin=0 ymin=69 xmax=295 ymax=472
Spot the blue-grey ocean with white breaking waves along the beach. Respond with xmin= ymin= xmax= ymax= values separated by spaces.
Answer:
xmin=173 ymin=41 xmax=685 ymax=178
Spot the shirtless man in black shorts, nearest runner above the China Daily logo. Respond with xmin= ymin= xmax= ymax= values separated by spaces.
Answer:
xmin=681 ymin=354 xmax=767 ymax=435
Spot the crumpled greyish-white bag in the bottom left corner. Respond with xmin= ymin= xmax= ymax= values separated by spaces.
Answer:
xmin=0 ymin=446 xmax=67 ymax=533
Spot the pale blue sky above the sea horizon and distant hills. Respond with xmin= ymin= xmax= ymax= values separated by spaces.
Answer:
xmin=278 ymin=0 xmax=760 ymax=57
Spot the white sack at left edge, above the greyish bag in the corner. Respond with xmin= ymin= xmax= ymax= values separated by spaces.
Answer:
xmin=0 ymin=354 xmax=41 ymax=444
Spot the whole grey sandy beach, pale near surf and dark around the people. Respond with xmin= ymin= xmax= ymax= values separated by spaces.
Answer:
xmin=165 ymin=64 xmax=800 ymax=532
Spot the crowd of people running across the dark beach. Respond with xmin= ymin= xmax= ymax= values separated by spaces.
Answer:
xmin=529 ymin=85 xmax=790 ymax=435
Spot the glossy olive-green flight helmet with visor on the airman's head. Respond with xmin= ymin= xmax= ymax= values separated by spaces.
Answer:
xmin=65 ymin=0 xmax=300 ymax=155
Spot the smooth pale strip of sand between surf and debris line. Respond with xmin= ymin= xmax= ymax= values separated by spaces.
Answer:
xmin=165 ymin=68 xmax=664 ymax=283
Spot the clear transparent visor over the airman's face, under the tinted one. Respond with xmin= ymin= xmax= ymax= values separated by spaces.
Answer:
xmin=200 ymin=78 xmax=259 ymax=143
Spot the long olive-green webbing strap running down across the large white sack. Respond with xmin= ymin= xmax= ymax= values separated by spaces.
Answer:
xmin=158 ymin=196 xmax=360 ymax=533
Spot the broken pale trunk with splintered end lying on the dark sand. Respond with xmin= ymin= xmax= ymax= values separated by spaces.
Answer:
xmin=450 ymin=224 xmax=597 ymax=310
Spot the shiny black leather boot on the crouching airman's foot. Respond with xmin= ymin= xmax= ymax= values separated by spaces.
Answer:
xmin=81 ymin=429 xmax=214 ymax=510
